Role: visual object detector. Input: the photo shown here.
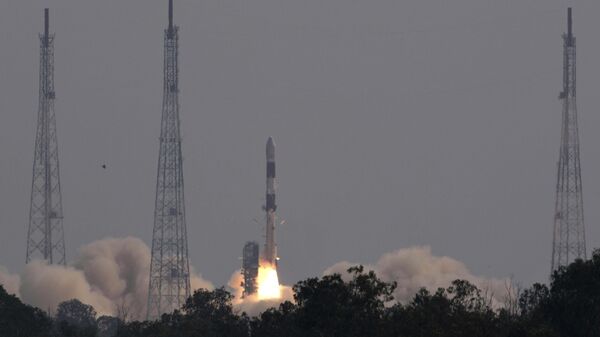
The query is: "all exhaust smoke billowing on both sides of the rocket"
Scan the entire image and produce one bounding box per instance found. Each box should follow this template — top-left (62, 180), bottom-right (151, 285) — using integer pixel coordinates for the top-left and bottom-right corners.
top-left (0, 243), bottom-right (509, 319)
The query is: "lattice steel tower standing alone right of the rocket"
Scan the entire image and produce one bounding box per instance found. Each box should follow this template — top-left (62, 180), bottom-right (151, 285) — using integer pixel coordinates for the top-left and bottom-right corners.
top-left (552, 8), bottom-right (586, 271)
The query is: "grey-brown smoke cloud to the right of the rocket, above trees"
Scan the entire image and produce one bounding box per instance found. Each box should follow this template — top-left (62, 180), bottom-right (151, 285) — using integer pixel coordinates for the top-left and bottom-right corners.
top-left (323, 246), bottom-right (510, 307)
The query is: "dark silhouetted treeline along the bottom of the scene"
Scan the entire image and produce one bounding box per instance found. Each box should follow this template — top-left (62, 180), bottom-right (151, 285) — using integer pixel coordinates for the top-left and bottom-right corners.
top-left (0, 251), bottom-right (600, 337)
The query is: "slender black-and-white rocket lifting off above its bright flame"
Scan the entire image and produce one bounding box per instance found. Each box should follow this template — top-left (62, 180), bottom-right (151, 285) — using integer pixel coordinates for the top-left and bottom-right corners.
top-left (263, 137), bottom-right (277, 266)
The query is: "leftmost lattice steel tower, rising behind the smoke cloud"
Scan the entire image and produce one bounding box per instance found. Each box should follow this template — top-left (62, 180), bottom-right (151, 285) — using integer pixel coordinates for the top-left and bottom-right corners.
top-left (25, 8), bottom-right (66, 265)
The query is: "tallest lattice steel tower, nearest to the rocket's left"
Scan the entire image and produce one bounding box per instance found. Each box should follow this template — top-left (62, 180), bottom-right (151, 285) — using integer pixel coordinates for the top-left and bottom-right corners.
top-left (147, 0), bottom-right (190, 319)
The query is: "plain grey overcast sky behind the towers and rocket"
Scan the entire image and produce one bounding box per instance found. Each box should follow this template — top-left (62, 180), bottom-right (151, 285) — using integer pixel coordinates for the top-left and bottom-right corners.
top-left (0, 0), bottom-right (600, 284)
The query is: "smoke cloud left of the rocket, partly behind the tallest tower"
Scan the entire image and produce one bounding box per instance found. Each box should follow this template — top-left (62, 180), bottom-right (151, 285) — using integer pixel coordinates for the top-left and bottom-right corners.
top-left (0, 237), bottom-right (213, 319)
